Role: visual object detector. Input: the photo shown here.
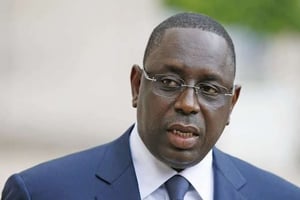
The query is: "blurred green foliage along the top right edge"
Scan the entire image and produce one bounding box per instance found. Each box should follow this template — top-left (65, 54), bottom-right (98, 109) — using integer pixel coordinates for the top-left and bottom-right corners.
top-left (163, 0), bottom-right (300, 33)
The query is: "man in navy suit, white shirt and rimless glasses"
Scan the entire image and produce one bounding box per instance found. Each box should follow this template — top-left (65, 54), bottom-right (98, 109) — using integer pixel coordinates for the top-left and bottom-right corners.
top-left (2, 13), bottom-right (300, 200)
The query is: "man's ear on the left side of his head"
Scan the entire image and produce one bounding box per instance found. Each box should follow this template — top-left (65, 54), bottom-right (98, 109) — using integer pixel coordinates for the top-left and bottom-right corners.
top-left (130, 65), bottom-right (142, 108)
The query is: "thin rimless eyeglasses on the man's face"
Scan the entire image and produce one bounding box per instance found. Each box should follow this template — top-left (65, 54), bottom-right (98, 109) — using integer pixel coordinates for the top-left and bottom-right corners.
top-left (143, 69), bottom-right (234, 103)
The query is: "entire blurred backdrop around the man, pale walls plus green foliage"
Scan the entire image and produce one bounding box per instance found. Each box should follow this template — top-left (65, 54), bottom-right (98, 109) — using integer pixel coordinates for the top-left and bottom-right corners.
top-left (0, 0), bottom-right (300, 190)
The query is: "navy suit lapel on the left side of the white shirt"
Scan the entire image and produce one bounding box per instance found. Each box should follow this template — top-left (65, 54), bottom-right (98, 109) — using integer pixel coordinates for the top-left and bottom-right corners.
top-left (95, 127), bottom-right (140, 200)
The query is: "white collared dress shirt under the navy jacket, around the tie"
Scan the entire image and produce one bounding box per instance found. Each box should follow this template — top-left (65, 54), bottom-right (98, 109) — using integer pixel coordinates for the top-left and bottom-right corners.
top-left (130, 125), bottom-right (214, 200)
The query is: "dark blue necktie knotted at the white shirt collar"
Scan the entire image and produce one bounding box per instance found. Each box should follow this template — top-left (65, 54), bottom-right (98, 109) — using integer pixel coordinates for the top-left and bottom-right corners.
top-left (165, 175), bottom-right (190, 200)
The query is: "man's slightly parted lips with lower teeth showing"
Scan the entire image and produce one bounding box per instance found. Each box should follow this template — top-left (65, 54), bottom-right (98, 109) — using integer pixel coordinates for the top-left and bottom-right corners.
top-left (167, 124), bottom-right (200, 149)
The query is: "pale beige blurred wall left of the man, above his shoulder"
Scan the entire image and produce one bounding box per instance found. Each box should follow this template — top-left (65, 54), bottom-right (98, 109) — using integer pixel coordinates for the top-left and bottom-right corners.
top-left (0, 0), bottom-right (163, 189)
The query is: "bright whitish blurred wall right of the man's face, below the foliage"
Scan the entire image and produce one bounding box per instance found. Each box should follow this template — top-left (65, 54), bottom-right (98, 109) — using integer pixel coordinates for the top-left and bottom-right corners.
top-left (219, 28), bottom-right (300, 186)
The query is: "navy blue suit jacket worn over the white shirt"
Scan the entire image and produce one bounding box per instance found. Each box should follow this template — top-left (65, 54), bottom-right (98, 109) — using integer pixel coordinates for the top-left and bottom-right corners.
top-left (1, 126), bottom-right (300, 200)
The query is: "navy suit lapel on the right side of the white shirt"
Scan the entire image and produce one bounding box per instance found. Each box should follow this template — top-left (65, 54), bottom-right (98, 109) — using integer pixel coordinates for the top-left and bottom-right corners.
top-left (213, 148), bottom-right (246, 200)
